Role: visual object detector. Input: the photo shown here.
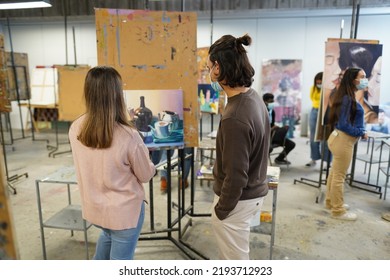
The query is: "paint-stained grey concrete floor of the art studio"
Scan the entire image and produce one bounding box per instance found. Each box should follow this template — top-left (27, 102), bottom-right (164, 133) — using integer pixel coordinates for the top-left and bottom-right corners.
top-left (5, 124), bottom-right (390, 260)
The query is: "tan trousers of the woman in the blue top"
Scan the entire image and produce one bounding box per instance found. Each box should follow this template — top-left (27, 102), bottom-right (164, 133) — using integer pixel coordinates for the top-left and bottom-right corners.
top-left (325, 129), bottom-right (359, 216)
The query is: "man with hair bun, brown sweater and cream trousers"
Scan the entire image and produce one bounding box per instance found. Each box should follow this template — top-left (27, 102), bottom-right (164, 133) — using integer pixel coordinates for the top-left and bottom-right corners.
top-left (207, 34), bottom-right (270, 260)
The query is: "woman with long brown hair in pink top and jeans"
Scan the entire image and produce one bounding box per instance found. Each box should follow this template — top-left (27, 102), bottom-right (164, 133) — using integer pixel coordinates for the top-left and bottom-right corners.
top-left (69, 66), bottom-right (155, 260)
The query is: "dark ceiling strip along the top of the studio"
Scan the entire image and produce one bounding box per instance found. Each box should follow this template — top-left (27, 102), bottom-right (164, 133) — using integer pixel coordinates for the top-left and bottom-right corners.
top-left (0, 0), bottom-right (390, 19)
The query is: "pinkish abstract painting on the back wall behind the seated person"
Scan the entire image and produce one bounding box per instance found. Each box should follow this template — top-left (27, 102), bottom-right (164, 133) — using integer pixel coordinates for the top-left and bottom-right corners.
top-left (261, 59), bottom-right (302, 138)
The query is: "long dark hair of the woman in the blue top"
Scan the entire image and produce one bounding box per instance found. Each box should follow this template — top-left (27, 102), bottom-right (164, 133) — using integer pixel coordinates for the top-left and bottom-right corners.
top-left (329, 67), bottom-right (362, 127)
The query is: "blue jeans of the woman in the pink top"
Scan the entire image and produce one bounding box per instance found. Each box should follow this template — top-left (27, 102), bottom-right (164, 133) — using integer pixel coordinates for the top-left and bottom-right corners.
top-left (93, 203), bottom-right (145, 260)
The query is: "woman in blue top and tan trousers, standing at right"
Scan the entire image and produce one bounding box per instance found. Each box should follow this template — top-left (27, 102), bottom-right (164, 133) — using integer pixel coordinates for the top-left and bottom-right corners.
top-left (325, 67), bottom-right (368, 221)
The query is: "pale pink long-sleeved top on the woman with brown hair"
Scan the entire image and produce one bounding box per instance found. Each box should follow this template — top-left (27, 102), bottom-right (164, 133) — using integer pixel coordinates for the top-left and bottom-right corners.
top-left (69, 116), bottom-right (155, 230)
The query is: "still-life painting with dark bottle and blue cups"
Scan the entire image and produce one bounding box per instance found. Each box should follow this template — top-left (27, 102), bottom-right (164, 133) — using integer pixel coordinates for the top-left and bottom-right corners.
top-left (124, 89), bottom-right (184, 149)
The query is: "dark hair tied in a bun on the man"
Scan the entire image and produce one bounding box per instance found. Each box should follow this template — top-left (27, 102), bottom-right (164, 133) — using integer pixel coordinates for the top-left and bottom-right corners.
top-left (209, 34), bottom-right (255, 88)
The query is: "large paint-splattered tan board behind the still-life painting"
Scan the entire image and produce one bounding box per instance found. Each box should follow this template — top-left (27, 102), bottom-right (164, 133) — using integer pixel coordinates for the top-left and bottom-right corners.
top-left (95, 9), bottom-right (199, 147)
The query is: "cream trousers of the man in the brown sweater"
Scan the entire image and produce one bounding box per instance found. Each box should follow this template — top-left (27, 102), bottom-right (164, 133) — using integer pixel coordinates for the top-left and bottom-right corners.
top-left (211, 195), bottom-right (264, 260)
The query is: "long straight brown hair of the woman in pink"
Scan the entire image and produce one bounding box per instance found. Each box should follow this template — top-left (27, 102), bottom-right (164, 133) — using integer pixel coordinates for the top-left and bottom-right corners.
top-left (78, 66), bottom-right (132, 149)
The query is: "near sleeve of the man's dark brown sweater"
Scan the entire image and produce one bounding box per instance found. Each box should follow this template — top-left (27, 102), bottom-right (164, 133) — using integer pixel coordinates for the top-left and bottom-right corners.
top-left (215, 118), bottom-right (251, 220)
